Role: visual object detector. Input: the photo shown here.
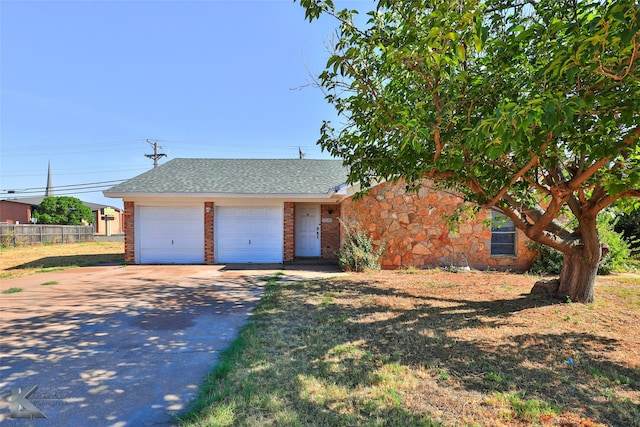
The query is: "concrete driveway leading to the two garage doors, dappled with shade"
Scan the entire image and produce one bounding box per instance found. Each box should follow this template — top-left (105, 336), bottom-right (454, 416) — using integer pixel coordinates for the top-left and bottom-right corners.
top-left (0, 265), bottom-right (344, 427)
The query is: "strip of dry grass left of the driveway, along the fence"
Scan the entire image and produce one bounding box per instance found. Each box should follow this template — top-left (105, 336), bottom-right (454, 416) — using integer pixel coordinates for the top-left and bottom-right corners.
top-left (0, 242), bottom-right (124, 279)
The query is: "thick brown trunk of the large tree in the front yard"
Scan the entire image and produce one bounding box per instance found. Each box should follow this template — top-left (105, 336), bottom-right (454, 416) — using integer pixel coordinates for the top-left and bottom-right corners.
top-left (558, 216), bottom-right (602, 303)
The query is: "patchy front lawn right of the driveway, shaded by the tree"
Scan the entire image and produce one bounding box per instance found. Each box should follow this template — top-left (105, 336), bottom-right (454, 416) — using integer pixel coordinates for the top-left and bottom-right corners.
top-left (181, 270), bottom-right (640, 427)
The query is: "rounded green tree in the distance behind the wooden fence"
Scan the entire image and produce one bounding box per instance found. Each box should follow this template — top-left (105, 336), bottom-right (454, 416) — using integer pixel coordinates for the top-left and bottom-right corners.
top-left (32, 196), bottom-right (93, 225)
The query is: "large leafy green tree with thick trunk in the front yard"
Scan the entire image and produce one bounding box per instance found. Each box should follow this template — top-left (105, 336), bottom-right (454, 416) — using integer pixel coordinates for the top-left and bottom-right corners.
top-left (300, 0), bottom-right (640, 302)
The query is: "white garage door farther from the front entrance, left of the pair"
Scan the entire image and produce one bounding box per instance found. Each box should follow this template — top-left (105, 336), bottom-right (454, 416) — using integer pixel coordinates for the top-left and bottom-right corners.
top-left (136, 206), bottom-right (204, 264)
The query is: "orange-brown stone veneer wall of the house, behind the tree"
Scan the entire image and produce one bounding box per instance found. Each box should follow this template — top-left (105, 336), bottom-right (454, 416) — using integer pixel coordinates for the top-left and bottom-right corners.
top-left (341, 182), bottom-right (536, 270)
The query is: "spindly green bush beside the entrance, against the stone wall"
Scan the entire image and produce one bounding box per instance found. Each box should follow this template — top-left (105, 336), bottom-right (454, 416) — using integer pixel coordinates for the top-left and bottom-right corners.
top-left (338, 221), bottom-right (384, 271)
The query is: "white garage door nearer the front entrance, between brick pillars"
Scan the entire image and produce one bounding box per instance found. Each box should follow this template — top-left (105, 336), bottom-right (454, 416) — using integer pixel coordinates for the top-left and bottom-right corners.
top-left (215, 206), bottom-right (283, 263)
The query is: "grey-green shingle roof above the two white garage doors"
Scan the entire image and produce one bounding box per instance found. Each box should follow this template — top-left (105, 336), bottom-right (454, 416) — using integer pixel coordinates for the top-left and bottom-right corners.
top-left (105, 159), bottom-right (348, 195)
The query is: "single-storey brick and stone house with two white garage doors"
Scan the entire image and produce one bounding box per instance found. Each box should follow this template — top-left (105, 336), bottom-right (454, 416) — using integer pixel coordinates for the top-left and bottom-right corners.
top-left (104, 159), bottom-right (533, 269)
